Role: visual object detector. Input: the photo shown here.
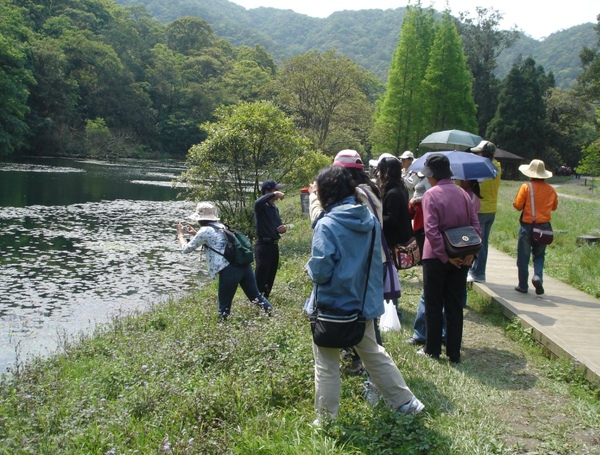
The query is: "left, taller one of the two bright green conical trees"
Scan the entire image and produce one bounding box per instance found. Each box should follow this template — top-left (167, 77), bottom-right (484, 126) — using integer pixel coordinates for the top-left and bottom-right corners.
top-left (372, 4), bottom-right (435, 155)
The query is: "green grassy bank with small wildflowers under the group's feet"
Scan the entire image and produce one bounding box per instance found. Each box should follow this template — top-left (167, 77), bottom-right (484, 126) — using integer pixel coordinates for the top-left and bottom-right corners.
top-left (0, 183), bottom-right (600, 454)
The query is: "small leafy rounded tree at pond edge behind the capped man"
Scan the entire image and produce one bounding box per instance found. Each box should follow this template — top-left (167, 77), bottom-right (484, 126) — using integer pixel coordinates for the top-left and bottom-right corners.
top-left (181, 101), bottom-right (309, 233)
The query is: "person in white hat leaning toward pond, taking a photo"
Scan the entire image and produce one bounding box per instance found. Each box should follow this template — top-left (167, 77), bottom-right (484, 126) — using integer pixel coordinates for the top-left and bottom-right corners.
top-left (177, 202), bottom-right (273, 321)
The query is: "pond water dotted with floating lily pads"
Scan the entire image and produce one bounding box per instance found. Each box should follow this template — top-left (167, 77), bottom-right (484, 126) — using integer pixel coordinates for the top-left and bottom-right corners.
top-left (0, 158), bottom-right (208, 373)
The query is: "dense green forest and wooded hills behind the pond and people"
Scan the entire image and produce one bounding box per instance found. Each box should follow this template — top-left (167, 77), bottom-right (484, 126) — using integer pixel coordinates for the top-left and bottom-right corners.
top-left (0, 0), bottom-right (598, 175)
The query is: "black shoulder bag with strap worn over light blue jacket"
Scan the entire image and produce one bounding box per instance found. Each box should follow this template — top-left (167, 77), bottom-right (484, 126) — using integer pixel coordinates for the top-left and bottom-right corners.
top-left (310, 224), bottom-right (377, 349)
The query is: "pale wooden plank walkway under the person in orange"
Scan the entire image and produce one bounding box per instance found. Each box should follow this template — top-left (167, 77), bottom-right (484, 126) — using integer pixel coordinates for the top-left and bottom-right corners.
top-left (473, 247), bottom-right (600, 385)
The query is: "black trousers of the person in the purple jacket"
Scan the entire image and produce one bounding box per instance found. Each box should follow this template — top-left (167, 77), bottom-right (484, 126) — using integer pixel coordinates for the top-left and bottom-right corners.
top-left (423, 259), bottom-right (469, 361)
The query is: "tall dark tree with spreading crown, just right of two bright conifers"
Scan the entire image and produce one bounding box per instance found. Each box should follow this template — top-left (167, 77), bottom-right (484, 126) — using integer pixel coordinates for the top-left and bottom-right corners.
top-left (457, 7), bottom-right (519, 136)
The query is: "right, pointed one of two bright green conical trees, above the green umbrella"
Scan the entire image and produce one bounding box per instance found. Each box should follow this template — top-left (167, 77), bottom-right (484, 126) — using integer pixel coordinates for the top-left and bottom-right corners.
top-left (421, 11), bottom-right (477, 132)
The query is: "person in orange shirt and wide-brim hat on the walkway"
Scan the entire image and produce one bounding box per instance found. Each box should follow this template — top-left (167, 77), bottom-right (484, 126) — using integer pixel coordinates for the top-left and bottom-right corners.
top-left (513, 159), bottom-right (558, 295)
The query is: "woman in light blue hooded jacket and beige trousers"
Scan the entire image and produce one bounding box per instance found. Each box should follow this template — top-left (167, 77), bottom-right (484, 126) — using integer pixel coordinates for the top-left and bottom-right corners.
top-left (305, 166), bottom-right (425, 424)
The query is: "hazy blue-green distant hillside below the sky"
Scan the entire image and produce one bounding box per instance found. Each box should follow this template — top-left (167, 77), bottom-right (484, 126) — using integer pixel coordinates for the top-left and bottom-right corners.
top-left (116, 0), bottom-right (600, 88)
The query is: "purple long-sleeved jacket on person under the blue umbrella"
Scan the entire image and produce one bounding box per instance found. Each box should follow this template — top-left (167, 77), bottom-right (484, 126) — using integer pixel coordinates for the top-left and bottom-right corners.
top-left (422, 179), bottom-right (481, 264)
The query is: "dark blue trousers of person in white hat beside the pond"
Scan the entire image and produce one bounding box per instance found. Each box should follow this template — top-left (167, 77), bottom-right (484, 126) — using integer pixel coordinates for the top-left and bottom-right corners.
top-left (219, 264), bottom-right (271, 315)
